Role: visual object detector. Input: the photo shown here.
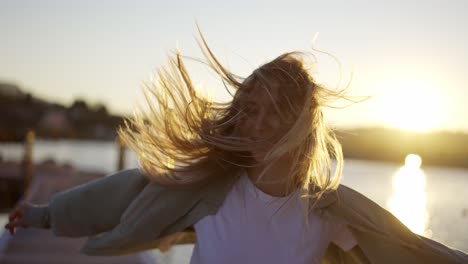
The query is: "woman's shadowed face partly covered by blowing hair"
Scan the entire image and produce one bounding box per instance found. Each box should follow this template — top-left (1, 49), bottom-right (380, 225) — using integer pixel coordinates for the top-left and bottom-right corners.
top-left (239, 85), bottom-right (294, 162)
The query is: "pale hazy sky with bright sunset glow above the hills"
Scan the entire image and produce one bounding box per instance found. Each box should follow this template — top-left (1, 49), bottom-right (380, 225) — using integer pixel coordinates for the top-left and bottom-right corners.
top-left (0, 0), bottom-right (468, 132)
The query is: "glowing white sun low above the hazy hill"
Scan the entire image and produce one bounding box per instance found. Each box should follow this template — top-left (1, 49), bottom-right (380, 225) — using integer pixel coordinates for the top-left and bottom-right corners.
top-left (379, 80), bottom-right (447, 132)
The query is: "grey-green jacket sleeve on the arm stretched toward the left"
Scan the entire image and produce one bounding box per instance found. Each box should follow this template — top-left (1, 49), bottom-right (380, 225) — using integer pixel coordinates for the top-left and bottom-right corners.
top-left (26, 169), bottom-right (149, 237)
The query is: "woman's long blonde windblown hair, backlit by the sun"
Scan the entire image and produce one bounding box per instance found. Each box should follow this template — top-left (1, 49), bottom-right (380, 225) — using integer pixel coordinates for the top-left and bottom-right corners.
top-left (118, 34), bottom-right (352, 206)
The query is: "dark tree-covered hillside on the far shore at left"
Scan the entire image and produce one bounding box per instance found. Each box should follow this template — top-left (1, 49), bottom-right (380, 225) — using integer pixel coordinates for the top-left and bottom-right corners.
top-left (0, 83), bottom-right (123, 141)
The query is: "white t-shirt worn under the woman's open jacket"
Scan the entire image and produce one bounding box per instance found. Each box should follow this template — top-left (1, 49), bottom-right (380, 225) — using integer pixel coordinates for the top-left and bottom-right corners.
top-left (190, 173), bottom-right (357, 264)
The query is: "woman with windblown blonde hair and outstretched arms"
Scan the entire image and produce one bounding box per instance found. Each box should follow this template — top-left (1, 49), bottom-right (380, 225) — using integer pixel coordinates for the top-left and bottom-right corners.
top-left (6, 32), bottom-right (465, 263)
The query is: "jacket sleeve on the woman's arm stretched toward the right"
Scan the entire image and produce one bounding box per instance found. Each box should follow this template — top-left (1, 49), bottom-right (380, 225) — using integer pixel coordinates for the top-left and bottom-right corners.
top-left (325, 185), bottom-right (468, 264)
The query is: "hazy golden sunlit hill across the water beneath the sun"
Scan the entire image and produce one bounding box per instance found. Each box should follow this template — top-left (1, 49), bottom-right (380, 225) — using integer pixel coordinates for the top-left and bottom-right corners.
top-left (337, 128), bottom-right (468, 168)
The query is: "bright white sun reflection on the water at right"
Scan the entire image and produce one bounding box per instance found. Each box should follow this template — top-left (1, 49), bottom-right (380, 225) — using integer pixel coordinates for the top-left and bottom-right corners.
top-left (388, 154), bottom-right (432, 237)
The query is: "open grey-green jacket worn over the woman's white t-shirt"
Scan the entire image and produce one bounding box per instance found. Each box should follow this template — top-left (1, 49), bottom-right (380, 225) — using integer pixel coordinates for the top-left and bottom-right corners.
top-left (27, 169), bottom-right (468, 264)
